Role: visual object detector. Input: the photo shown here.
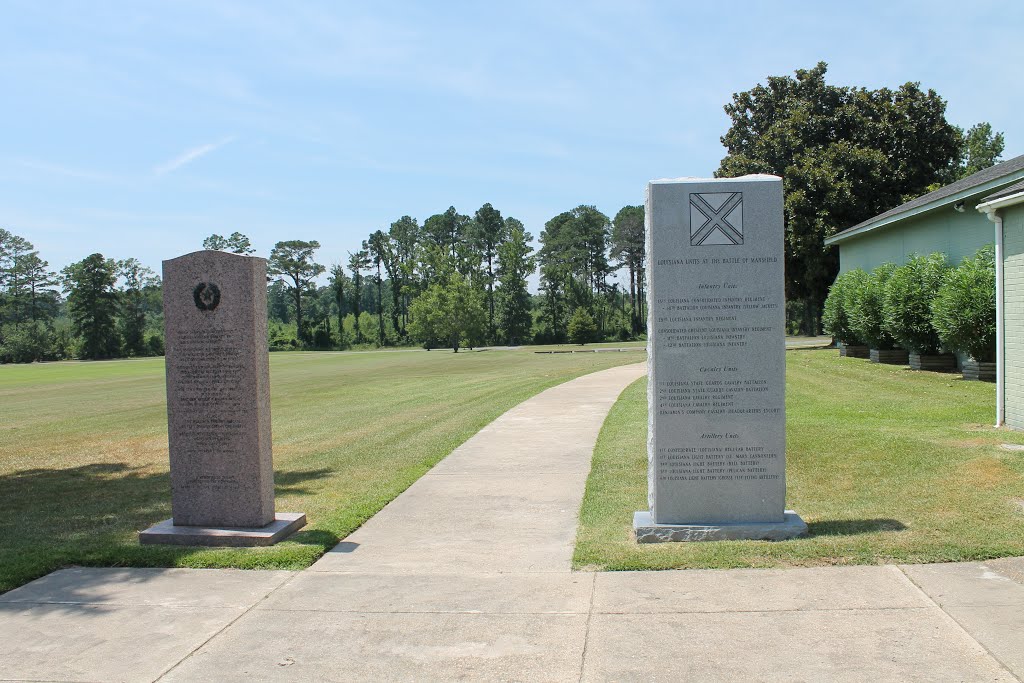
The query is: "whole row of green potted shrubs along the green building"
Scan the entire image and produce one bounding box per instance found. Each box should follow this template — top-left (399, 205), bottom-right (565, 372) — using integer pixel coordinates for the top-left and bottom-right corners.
top-left (822, 246), bottom-right (995, 361)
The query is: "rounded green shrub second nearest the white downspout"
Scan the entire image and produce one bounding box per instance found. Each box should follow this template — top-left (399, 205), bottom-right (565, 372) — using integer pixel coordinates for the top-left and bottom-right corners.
top-left (882, 253), bottom-right (949, 354)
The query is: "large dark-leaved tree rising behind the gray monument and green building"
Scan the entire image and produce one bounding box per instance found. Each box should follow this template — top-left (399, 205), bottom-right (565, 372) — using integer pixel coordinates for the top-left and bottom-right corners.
top-left (716, 61), bottom-right (963, 332)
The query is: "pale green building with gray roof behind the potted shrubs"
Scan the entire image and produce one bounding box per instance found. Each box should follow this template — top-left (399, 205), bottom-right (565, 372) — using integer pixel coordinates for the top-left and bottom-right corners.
top-left (825, 155), bottom-right (1024, 429)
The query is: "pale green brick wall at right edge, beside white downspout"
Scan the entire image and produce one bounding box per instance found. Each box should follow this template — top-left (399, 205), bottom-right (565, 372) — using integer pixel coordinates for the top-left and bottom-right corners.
top-left (999, 204), bottom-right (1024, 429)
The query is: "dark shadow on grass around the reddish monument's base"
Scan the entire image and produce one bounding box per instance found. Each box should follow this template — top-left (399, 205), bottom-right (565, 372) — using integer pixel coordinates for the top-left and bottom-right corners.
top-left (0, 463), bottom-right (339, 593)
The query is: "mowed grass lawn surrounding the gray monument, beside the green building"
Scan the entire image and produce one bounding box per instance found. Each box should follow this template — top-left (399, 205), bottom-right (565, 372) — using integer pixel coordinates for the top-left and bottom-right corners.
top-left (574, 349), bottom-right (1024, 569)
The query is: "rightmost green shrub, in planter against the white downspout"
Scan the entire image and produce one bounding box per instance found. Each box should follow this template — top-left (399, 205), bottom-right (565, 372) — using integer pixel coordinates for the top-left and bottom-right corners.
top-left (932, 246), bottom-right (995, 362)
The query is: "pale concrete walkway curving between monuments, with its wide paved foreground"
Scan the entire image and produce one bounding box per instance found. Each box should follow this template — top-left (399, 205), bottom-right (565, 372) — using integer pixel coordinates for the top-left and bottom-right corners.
top-left (0, 365), bottom-right (1024, 683)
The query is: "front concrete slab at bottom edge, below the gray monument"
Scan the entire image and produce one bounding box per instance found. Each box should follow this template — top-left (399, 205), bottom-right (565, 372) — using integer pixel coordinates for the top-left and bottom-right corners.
top-left (581, 610), bottom-right (1016, 683)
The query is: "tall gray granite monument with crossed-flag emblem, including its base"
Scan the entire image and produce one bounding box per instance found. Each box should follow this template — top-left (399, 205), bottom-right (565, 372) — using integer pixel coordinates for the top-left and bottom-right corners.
top-left (633, 175), bottom-right (807, 543)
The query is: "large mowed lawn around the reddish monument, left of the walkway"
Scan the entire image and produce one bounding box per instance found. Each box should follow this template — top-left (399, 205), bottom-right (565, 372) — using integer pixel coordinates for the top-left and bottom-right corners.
top-left (0, 349), bottom-right (642, 592)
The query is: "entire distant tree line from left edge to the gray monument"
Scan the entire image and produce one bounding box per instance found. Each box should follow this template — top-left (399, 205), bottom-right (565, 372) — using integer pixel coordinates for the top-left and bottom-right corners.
top-left (0, 204), bottom-right (646, 362)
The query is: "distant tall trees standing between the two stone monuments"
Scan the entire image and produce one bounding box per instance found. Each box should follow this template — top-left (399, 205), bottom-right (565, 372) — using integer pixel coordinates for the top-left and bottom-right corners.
top-left (256, 204), bottom-right (645, 351)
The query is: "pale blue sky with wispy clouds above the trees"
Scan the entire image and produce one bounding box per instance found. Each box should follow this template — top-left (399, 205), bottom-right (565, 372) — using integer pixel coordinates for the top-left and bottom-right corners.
top-left (0, 0), bottom-right (1024, 282)
